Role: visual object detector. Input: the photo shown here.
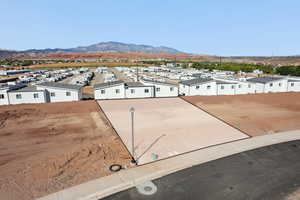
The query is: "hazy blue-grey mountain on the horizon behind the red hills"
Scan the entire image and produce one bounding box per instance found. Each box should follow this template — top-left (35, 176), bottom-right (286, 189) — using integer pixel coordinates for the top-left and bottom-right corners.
top-left (23, 42), bottom-right (183, 54)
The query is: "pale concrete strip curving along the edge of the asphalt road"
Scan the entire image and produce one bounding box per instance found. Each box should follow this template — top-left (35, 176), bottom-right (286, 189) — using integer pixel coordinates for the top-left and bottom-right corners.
top-left (38, 130), bottom-right (300, 200)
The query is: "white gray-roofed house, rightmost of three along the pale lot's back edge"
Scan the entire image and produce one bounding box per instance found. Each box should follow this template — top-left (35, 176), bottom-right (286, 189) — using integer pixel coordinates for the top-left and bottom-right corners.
top-left (140, 79), bottom-right (178, 97)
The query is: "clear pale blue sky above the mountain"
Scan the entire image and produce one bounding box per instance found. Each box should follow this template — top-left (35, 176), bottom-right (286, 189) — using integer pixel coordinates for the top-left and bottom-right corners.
top-left (0, 0), bottom-right (300, 56)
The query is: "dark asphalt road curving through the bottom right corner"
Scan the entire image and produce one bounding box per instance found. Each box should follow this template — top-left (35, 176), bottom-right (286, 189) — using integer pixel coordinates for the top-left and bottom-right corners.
top-left (105, 140), bottom-right (300, 200)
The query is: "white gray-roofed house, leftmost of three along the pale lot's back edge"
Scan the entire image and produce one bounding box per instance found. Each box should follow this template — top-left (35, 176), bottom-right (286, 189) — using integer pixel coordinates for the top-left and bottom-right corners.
top-left (94, 81), bottom-right (125, 99)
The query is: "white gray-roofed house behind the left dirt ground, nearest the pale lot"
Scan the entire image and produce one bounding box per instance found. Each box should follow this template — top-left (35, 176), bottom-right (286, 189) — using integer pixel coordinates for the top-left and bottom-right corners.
top-left (36, 82), bottom-right (82, 102)
